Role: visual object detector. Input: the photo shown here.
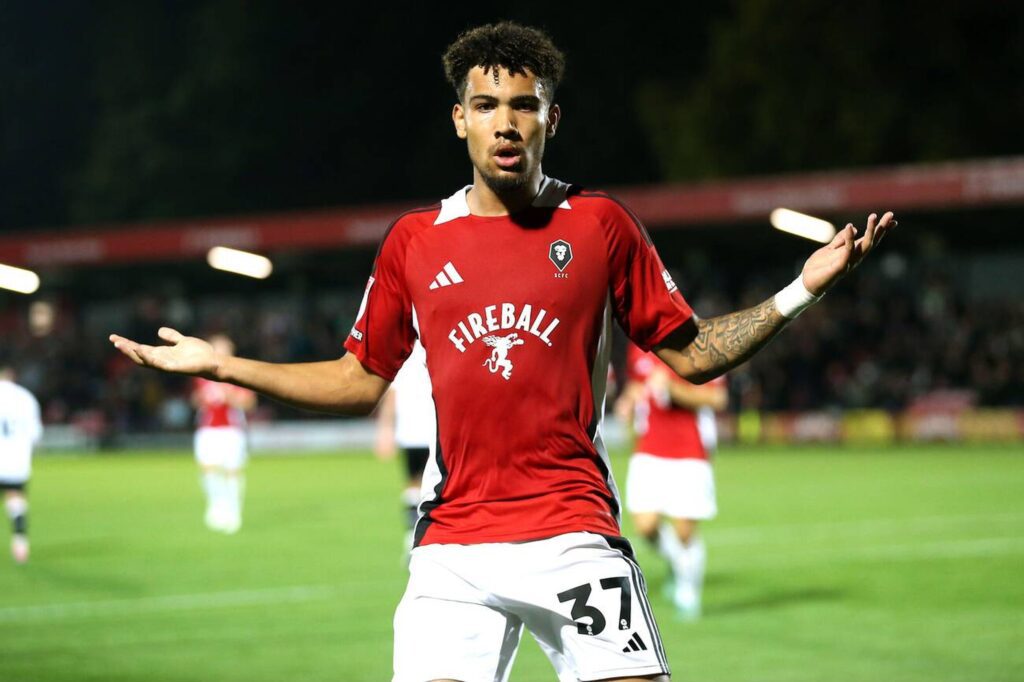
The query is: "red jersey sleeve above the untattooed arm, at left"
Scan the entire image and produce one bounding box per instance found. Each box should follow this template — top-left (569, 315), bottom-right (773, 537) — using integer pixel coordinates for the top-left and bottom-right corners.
top-left (345, 227), bottom-right (417, 381)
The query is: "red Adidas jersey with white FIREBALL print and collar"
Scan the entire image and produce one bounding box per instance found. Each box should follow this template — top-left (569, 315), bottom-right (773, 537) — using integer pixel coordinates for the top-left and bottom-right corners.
top-left (345, 178), bottom-right (692, 545)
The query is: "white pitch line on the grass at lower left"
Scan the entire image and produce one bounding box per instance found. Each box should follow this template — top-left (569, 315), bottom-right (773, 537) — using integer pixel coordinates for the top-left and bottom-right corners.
top-left (0, 585), bottom-right (341, 624)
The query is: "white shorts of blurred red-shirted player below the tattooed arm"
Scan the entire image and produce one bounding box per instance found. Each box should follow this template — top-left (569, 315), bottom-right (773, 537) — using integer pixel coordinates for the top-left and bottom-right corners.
top-left (626, 453), bottom-right (718, 520)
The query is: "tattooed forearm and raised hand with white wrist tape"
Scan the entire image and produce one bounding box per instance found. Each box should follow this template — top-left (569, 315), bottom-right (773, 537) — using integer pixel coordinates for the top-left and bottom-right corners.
top-left (654, 212), bottom-right (896, 383)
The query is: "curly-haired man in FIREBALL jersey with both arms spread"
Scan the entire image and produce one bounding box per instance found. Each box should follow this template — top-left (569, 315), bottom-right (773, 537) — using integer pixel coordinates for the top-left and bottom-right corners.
top-left (111, 23), bottom-right (894, 682)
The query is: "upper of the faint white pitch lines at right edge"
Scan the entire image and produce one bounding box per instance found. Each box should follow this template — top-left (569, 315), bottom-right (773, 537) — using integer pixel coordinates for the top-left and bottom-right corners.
top-left (708, 512), bottom-right (1024, 545)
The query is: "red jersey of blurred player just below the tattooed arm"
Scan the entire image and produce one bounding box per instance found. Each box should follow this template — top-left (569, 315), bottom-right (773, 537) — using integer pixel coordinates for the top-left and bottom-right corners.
top-left (626, 344), bottom-right (725, 460)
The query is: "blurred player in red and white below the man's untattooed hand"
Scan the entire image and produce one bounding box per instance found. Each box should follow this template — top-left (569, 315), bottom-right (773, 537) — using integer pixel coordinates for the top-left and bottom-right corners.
top-left (191, 335), bottom-right (256, 534)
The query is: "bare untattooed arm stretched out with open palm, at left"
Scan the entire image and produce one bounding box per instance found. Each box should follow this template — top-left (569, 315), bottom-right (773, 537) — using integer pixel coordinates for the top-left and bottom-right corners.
top-left (111, 327), bottom-right (389, 415)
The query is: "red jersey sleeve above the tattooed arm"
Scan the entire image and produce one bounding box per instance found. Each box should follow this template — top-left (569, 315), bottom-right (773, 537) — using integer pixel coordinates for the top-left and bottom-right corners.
top-left (605, 198), bottom-right (693, 351)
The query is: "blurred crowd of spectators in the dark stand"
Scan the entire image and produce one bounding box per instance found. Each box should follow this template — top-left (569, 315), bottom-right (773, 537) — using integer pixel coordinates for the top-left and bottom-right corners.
top-left (0, 258), bottom-right (1024, 433)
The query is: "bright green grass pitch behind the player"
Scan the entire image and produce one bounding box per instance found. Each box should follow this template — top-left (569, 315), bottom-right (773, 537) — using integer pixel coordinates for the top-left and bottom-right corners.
top-left (0, 445), bottom-right (1024, 682)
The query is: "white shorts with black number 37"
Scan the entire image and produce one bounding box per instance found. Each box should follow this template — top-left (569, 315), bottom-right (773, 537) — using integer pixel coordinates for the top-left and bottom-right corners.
top-left (394, 532), bottom-right (669, 682)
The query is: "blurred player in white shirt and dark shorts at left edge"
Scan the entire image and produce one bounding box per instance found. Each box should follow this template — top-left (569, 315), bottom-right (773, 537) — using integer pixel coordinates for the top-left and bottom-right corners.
top-left (0, 364), bottom-right (43, 563)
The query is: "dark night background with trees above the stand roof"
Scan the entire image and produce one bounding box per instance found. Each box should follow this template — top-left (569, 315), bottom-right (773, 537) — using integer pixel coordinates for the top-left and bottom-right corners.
top-left (0, 0), bottom-right (1024, 229)
